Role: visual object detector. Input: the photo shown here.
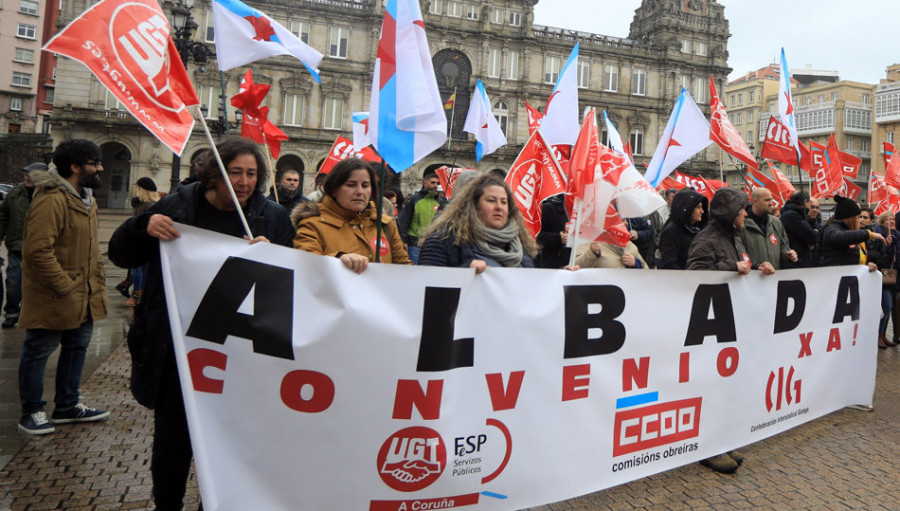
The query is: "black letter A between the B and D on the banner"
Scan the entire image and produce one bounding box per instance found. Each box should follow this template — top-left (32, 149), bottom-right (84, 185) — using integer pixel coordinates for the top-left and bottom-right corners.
top-left (684, 284), bottom-right (737, 346)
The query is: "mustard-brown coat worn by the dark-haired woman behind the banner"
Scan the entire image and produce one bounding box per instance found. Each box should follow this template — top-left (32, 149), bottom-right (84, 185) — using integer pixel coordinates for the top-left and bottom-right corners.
top-left (291, 195), bottom-right (412, 264)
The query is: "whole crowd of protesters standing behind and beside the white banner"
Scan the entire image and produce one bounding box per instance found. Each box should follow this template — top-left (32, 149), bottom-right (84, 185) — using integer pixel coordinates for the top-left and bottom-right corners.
top-left (8, 137), bottom-right (900, 510)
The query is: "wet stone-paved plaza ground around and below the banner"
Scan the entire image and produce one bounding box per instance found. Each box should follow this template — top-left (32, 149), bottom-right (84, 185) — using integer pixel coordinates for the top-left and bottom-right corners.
top-left (0, 210), bottom-right (900, 511)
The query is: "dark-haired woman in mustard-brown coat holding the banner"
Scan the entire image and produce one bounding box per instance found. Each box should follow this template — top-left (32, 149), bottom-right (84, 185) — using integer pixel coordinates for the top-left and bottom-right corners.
top-left (291, 158), bottom-right (412, 273)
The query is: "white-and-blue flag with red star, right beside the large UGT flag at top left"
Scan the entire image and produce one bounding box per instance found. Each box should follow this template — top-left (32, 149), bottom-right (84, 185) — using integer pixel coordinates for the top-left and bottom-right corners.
top-left (212, 0), bottom-right (322, 82)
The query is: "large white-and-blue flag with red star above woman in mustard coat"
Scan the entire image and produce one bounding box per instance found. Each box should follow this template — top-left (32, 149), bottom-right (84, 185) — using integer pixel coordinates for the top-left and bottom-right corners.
top-left (369, 0), bottom-right (447, 172)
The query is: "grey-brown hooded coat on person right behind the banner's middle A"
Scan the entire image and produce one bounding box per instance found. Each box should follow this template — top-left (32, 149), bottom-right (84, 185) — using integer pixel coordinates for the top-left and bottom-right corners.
top-left (687, 188), bottom-right (750, 271)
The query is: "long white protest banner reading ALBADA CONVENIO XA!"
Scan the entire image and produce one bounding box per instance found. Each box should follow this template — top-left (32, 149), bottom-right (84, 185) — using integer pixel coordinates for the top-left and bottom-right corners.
top-left (161, 226), bottom-right (881, 510)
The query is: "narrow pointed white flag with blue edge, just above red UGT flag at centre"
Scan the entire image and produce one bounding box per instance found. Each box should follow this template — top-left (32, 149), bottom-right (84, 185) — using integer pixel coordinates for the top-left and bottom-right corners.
top-left (540, 43), bottom-right (580, 145)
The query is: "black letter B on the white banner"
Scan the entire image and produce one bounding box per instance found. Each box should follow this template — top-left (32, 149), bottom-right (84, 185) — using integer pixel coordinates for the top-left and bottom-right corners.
top-left (563, 286), bottom-right (625, 358)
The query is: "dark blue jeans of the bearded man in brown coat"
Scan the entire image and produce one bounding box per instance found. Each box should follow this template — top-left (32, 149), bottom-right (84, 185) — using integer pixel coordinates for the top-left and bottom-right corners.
top-left (19, 321), bottom-right (94, 414)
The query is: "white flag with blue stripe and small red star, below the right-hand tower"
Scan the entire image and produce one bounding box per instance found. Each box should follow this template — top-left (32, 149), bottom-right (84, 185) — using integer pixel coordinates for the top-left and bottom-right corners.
top-left (644, 88), bottom-right (712, 188)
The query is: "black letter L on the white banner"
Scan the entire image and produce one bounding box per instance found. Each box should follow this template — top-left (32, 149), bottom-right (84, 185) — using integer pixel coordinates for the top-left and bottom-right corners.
top-left (416, 287), bottom-right (475, 371)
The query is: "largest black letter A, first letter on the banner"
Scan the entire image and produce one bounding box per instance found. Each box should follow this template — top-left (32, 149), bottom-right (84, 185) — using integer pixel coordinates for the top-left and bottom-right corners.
top-left (187, 257), bottom-right (294, 360)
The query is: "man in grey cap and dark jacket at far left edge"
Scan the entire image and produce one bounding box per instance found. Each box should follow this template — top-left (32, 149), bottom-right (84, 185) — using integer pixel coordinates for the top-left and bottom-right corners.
top-left (0, 162), bottom-right (38, 328)
